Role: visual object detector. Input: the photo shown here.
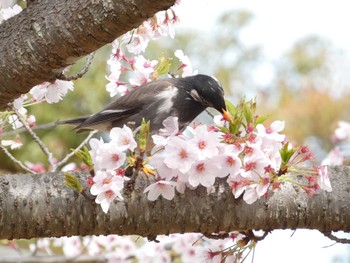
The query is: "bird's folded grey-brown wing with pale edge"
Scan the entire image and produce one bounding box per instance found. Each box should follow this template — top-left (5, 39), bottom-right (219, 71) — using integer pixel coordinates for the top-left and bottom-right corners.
top-left (75, 79), bottom-right (173, 130)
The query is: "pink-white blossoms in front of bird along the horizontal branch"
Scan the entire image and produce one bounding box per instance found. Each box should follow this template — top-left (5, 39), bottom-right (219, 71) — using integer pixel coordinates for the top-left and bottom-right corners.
top-left (86, 112), bottom-right (331, 216)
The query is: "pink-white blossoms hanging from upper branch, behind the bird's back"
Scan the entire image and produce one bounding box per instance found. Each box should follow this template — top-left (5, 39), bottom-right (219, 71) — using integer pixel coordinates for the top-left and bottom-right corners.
top-left (106, 5), bottom-right (198, 97)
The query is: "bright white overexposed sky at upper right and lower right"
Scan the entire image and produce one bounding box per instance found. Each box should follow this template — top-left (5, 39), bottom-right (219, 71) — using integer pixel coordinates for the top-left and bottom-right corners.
top-left (176, 0), bottom-right (350, 263)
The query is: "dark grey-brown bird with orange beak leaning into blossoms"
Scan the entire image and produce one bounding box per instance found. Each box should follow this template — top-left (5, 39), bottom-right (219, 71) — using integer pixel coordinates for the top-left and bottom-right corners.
top-left (59, 74), bottom-right (230, 139)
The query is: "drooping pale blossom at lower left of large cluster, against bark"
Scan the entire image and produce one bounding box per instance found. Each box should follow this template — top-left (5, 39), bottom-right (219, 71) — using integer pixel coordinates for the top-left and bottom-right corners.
top-left (143, 180), bottom-right (176, 201)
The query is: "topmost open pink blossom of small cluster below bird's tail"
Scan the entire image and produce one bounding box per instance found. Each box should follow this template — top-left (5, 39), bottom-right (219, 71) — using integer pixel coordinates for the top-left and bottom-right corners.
top-left (109, 125), bottom-right (137, 151)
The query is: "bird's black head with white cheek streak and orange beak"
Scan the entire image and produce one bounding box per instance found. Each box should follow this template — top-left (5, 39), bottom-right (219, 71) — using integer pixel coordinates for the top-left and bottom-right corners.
top-left (188, 74), bottom-right (230, 120)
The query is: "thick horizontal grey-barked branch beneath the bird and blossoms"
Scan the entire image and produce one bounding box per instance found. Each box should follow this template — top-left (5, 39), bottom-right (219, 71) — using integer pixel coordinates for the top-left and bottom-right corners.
top-left (0, 166), bottom-right (350, 239)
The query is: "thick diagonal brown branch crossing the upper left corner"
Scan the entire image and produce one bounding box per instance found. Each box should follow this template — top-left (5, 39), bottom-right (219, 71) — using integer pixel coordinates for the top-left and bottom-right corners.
top-left (0, 0), bottom-right (175, 109)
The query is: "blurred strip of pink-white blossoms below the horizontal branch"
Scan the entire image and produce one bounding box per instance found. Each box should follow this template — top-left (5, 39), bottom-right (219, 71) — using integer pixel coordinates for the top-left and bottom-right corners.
top-left (18, 231), bottom-right (246, 262)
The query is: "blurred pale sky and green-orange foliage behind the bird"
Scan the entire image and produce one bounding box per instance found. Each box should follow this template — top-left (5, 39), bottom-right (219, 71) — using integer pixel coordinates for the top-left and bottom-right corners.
top-left (0, 0), bottom-right (350, 263)
